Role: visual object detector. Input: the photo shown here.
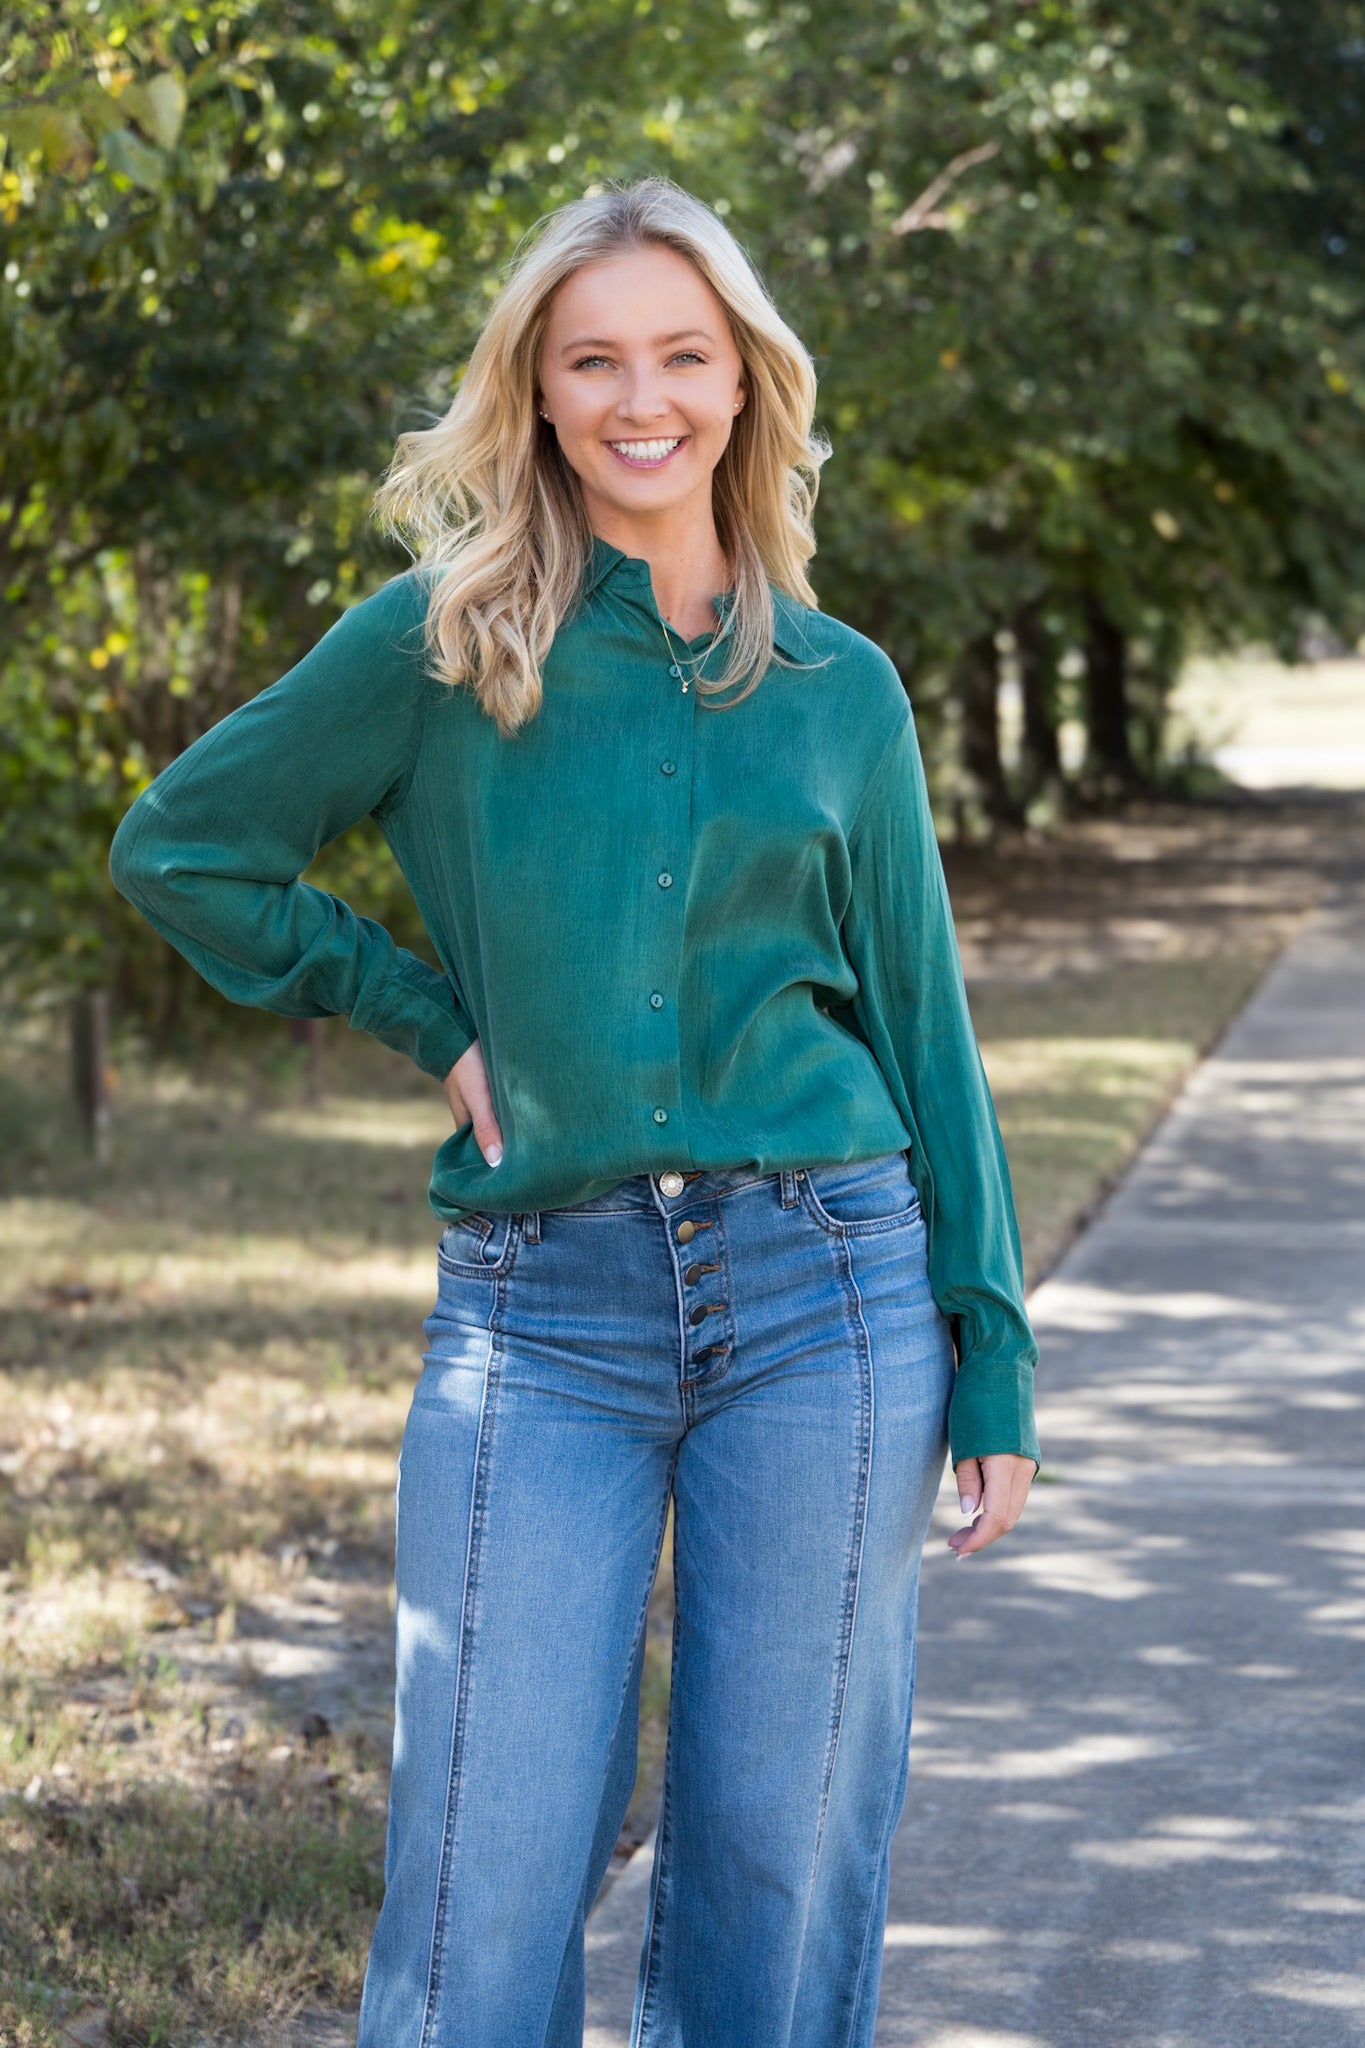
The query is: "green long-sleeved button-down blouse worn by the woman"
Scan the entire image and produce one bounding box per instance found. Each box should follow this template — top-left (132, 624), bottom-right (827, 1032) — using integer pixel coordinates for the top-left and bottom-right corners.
top-left (111, 541), bottom-right (1038, 1462)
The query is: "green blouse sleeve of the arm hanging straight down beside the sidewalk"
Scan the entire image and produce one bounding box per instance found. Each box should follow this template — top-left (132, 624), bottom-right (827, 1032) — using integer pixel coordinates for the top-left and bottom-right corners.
top-left (843, 702), bottom-right (1040, 1464)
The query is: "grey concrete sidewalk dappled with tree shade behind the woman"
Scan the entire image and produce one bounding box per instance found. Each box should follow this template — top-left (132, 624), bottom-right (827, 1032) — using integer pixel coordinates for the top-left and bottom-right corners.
top-left (585, 891), bottom-right (1365, 2048)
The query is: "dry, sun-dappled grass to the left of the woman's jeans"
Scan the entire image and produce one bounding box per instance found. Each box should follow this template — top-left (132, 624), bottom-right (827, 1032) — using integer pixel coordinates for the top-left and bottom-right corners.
top-left (0, 1044), bottom-right (440, 2048)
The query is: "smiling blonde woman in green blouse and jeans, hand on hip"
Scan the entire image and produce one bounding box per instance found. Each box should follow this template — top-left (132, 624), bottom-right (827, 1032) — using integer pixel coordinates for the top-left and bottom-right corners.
top-left (113, 178), bottom-right (1038, 2048)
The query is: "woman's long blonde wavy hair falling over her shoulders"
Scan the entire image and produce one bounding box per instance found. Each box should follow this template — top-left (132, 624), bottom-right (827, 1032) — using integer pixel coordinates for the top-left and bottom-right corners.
top-left (372, 178), bottom-right (829, 735)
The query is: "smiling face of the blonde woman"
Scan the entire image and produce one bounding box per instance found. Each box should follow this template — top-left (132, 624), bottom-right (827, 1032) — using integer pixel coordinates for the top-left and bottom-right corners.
top-left (536, 244), bottom-right (745, 539)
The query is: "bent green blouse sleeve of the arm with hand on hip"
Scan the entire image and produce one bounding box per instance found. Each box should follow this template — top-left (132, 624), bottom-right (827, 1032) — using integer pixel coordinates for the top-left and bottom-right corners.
top-left (108, 580), bottom-right (477, 1079)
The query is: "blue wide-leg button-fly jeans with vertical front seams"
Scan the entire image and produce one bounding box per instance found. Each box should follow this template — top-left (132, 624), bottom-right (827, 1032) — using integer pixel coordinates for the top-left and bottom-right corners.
top-left (358, 1153), bottom-right (954, 2048)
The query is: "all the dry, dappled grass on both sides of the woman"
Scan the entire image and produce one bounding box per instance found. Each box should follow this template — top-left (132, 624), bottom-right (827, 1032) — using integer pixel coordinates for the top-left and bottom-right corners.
top-left (0, 790), bottom-right (1363, 2048)
